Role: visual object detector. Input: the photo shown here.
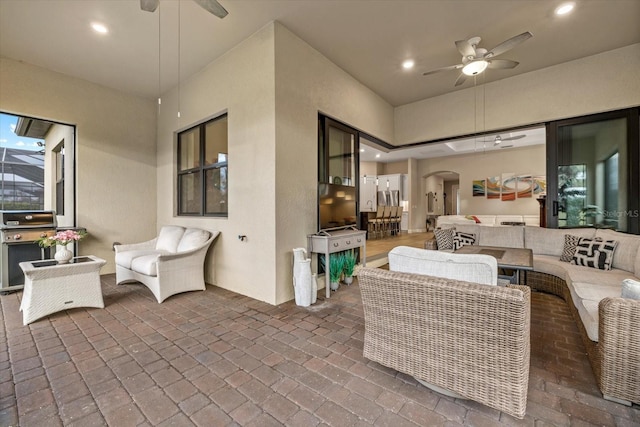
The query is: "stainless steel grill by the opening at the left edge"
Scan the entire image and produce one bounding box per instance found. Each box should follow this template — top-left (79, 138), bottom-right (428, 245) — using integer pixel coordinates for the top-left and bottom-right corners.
top-left (0, 211), bottom-right (56, 292)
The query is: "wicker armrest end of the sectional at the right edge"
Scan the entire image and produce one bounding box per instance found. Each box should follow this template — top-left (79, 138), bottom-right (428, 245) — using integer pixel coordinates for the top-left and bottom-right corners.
top-left (598, 298), bottom-right (640, 404)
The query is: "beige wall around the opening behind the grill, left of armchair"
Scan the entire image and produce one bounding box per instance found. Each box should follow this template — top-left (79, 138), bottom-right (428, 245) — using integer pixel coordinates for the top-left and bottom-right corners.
top-left (0, 58), bottom-right (156, 274)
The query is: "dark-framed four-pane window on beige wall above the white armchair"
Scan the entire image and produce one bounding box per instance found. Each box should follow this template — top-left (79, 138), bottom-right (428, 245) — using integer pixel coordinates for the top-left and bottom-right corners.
top-left (178, 114), bottom-right (229, 217)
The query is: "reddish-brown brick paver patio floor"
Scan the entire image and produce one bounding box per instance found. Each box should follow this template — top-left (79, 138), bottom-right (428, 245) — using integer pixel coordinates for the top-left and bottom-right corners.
top-left (0, 275), bottom-right (640, 427)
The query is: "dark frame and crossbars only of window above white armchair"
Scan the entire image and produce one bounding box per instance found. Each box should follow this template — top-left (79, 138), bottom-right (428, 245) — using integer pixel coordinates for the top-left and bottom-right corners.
top-left (176, 113), bottom-right (229, 218)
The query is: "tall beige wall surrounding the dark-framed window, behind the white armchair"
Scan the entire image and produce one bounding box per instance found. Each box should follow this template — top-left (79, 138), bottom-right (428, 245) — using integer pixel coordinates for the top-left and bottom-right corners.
top-left (157, 25), bottom-right (276, 304)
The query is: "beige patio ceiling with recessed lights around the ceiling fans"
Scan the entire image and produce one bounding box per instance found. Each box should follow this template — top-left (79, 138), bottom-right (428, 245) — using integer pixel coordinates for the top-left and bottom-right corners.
top-left (0, 0), bottom-right (640, 106)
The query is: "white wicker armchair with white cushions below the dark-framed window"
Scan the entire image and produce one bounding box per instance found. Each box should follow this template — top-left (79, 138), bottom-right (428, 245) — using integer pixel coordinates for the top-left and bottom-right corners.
top-left (114, 226), bottom-right (220, 303)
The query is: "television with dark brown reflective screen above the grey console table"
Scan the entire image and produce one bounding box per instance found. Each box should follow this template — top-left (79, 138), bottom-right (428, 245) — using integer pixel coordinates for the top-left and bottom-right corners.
top-left (318, 183), bottom-right (358, 230)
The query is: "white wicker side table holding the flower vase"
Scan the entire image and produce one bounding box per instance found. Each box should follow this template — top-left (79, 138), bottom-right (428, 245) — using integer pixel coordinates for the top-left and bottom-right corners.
top-left (20, 256), bottom-right (106, 325)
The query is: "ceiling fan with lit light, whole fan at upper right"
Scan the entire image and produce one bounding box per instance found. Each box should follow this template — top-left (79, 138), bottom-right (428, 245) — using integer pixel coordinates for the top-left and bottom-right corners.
top-left (423, 31), bottom-right (533, 86)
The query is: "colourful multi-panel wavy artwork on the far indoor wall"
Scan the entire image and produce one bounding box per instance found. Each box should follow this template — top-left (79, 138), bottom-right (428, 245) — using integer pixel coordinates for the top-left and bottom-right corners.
top-left (472, 172), bottom-right (547, 201)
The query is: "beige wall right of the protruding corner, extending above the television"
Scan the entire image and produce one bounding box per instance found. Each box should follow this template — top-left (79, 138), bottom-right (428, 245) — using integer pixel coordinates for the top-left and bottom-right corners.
top-left (275, 23), bottom-right (393, 302)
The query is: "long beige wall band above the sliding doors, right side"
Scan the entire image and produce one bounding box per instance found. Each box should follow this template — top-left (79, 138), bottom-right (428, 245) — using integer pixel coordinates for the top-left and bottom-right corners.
top-left (394, 44), bottom-right (640, 145)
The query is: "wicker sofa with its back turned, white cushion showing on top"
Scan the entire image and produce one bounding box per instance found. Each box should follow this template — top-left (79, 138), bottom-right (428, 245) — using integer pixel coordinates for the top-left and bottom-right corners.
top-left (358, 247), bottom-right (530, 418)
